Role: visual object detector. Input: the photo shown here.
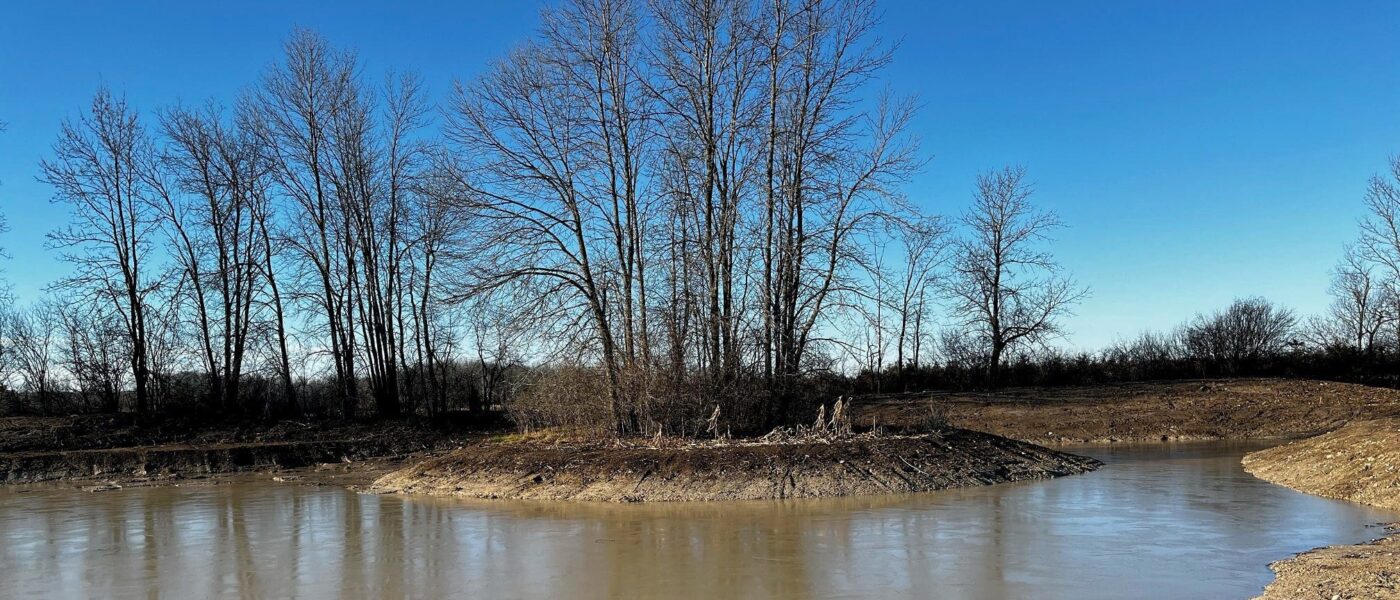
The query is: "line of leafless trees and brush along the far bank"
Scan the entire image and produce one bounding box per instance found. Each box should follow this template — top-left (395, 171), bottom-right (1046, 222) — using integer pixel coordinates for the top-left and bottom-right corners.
top-left (32, 0), bottom-right (1344, 435)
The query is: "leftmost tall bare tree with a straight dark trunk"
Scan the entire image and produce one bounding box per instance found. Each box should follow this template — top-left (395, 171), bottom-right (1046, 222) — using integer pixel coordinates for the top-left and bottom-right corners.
top-left (41, 88), bottom-right (158, 413)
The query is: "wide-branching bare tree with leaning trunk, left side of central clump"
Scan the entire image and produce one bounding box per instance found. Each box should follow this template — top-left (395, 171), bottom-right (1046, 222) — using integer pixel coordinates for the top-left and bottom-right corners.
top-left (447, 1), bottom-right (650, 428)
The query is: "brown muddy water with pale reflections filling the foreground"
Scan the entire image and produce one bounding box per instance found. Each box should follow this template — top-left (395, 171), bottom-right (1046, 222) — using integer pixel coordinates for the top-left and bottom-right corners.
top-left (0, 443), bottom-right (1400, 600)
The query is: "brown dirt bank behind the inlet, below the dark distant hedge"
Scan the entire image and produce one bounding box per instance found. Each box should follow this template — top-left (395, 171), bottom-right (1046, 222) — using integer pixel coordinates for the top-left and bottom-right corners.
top-left (855, 379), bottom-right (1400, 443)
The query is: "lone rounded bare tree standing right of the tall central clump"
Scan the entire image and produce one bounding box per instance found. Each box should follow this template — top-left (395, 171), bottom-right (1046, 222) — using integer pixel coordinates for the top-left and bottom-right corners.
top-left (948, 166), bottom-right (1088, 386)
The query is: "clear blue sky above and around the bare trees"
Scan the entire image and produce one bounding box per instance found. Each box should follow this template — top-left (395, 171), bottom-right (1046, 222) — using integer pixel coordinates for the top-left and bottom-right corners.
top-left (0, 0), bottom-right (1400, 347)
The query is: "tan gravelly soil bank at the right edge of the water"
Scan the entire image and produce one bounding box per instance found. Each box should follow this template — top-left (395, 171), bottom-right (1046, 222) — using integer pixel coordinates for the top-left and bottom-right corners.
top-left (1243, 420), bottom-right (1400, 600)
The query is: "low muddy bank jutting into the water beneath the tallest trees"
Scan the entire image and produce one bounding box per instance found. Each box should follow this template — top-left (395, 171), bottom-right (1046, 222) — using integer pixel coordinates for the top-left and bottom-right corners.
top-left (371, 429), bottom-right (1100, 502)
